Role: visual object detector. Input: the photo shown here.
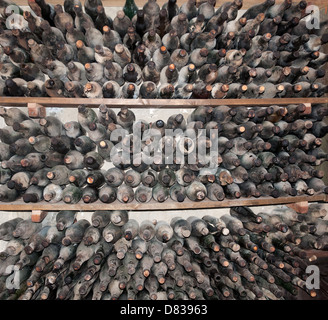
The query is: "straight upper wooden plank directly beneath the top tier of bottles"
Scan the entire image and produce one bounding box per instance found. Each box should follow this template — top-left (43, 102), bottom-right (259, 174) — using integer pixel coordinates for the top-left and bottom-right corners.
top-left (0, 97), bottom-right (328, 109)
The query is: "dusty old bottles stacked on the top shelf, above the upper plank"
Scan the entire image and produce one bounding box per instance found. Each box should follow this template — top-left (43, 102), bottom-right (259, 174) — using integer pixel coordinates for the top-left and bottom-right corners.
top-left (0, 0), bottom-right (328, 99)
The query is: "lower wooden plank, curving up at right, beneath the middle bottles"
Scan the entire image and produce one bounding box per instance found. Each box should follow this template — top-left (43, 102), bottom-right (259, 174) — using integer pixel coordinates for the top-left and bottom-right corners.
top-left (0, 194), bottom-right (327, 211)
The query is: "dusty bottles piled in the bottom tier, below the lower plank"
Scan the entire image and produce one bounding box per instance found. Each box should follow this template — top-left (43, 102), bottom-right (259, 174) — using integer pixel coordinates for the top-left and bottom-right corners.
top-left (0, 204), bottom-right (328, 300)
